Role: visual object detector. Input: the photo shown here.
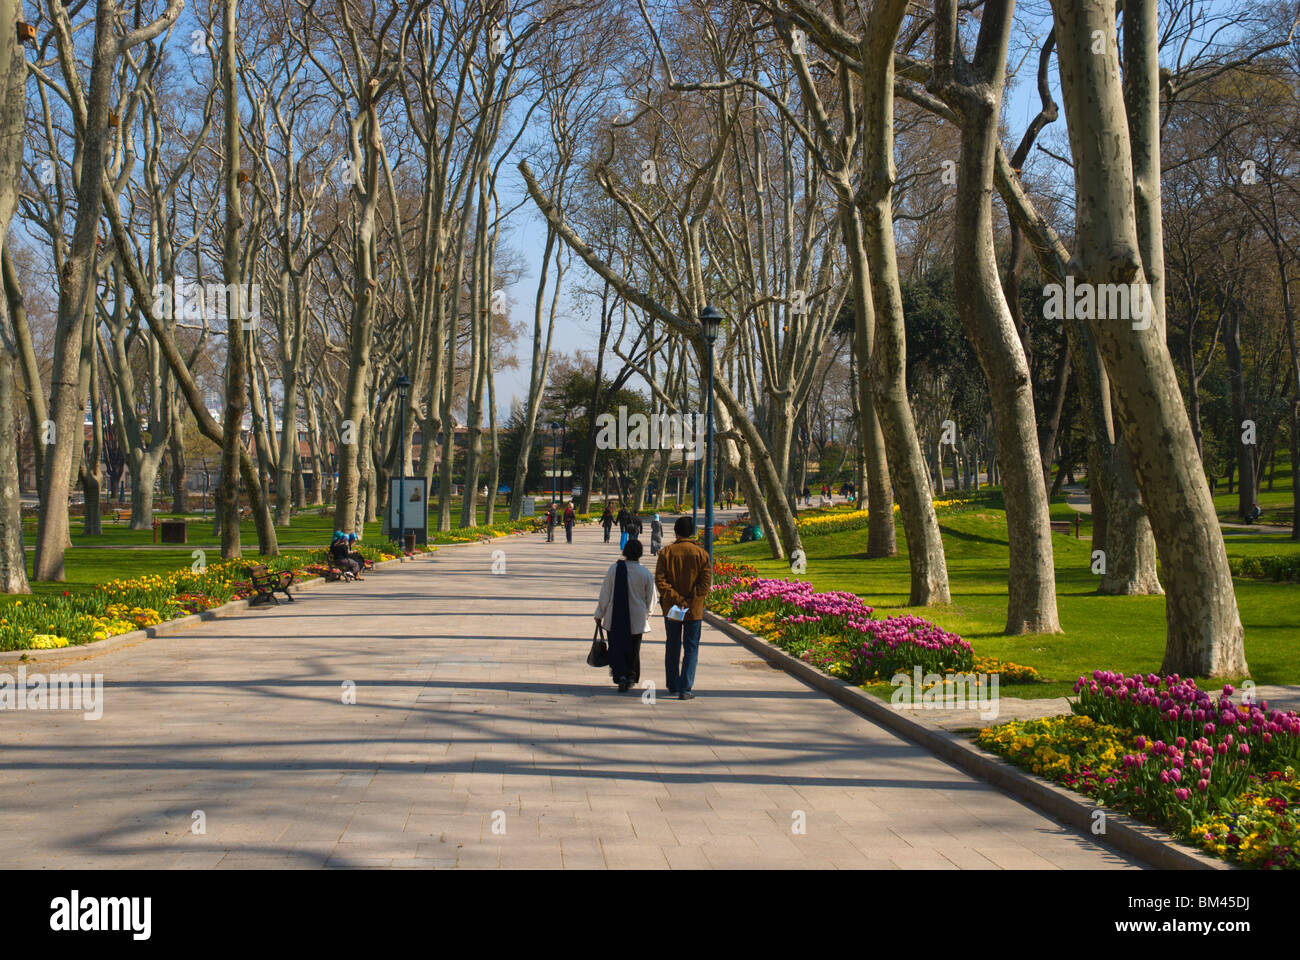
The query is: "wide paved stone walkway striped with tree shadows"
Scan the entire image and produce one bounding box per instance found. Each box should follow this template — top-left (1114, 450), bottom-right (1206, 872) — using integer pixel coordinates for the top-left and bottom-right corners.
top-left (0, 527), bottom-right (1132, 869)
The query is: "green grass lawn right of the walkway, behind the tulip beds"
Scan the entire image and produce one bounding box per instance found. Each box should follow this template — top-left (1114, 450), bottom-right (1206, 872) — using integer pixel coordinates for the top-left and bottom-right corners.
top-left (719, 494), bottom-right (1300, 697)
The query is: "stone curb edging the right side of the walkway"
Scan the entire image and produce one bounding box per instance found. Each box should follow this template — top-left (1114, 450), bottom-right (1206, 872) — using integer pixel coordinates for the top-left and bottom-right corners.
top-left (705, 610), bottom-right (1239, 870)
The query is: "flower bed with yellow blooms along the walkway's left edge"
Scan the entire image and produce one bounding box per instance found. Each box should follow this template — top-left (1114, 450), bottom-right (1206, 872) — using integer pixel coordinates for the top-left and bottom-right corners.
top-left (0, 544), bottom-right (394, 650)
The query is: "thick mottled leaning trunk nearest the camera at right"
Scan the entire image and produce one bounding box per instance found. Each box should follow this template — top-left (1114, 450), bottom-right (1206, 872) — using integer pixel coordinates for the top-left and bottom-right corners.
top-left (1050, 0), bottom-right (1247, 676)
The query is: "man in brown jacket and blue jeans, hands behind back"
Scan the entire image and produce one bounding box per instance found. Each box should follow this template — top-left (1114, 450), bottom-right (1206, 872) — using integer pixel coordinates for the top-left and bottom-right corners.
top-left (654, 516), bottom-right (714, 700)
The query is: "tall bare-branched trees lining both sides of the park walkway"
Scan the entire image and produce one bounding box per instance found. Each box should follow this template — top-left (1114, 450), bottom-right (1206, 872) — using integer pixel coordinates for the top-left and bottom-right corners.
top-left (0, 0), bottom-right (1300, 674)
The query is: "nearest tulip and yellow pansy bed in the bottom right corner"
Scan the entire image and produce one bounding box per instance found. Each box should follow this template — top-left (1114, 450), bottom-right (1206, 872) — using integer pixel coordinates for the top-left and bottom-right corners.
top-left (978, 670), bottom-right (1300, 869)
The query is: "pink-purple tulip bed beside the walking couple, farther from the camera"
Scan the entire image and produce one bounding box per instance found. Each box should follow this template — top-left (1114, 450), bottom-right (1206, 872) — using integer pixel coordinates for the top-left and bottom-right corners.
top-left (709, 563), bottom-right (975, 684)
